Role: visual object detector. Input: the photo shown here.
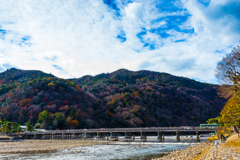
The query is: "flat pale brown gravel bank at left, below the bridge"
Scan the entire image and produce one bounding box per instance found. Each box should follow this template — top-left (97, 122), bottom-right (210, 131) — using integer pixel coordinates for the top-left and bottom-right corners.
top-left (0, 140), bottom-right (107, 154)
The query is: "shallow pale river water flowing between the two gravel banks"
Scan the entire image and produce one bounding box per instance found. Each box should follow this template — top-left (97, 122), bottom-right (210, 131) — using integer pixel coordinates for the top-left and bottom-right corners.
top-left (0, 136), bottom-right (207, 160)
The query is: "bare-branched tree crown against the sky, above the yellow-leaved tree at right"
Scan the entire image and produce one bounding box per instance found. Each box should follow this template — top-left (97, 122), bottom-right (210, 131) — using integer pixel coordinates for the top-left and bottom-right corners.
top-left (216, 46), bottom-right (240, 97)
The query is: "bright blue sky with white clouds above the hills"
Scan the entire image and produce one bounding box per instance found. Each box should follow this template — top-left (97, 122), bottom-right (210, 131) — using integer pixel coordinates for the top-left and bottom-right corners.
top-left (0, 0), bottom-right (240, 84)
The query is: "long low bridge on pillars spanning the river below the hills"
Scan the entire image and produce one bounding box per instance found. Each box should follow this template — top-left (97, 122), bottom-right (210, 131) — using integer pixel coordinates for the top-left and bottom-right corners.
top-left (25, 127), bottom-right (216, 142)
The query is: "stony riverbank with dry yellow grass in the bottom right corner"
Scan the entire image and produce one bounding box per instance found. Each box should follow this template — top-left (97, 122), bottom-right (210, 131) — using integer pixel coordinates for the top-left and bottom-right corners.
top-left (154, 135), bottom-right (240, 160)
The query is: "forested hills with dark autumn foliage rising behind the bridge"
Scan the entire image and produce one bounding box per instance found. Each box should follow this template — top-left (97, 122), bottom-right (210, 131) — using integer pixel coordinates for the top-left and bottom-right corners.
top-left (0, 69), bottom-right (226, 128)
